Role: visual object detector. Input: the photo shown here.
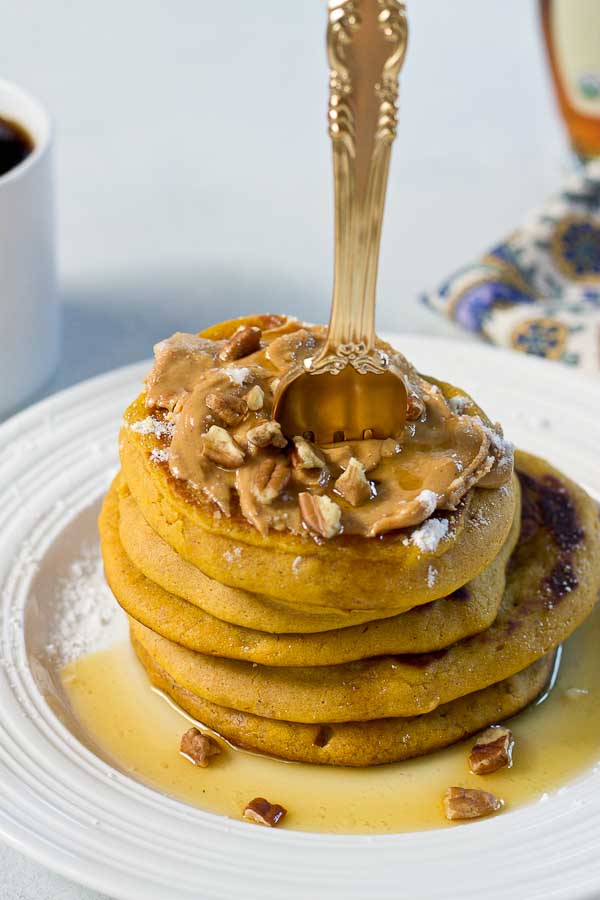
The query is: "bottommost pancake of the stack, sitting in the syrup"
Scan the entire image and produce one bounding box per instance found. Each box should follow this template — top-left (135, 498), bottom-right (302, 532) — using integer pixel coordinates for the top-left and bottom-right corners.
top-left (132, 635), bottom-right (554, 766)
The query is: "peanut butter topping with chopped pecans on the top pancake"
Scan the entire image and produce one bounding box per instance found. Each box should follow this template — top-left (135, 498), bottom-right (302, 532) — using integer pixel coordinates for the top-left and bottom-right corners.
top-left (133, 317), bottom-right (513, 539)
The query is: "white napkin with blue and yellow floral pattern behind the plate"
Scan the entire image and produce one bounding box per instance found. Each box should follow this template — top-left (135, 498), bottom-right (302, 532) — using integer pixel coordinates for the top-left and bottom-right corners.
top-left (422, 159), bottom-right (600, 375)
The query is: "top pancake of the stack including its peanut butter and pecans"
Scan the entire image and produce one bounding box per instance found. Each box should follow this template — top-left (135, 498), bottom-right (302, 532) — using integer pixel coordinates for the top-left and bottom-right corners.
top-left (120, 315), bottom-right (516, 612)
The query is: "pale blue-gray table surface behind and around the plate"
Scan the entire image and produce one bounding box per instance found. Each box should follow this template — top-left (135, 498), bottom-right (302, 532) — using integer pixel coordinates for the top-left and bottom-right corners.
top-left (0, 0), bottom-right (567, 900)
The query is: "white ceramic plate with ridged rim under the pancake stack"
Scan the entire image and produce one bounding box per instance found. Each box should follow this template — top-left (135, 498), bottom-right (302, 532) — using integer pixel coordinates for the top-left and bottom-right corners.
top-left (0, 336), bottom-right (600, 900)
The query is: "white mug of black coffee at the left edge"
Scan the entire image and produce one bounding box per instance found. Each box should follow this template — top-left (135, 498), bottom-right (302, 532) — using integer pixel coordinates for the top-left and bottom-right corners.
top-left (0, 80), bottom-right (60, 416)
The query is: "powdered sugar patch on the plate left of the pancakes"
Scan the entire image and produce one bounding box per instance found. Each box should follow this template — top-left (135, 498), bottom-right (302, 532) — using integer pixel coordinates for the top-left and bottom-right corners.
top-left (46, 546), bottom-right (124, 665)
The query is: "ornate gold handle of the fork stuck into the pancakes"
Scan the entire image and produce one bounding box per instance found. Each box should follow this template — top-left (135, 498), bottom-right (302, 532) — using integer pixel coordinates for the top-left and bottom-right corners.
top-left (309, 0), bottom-right (408, 374)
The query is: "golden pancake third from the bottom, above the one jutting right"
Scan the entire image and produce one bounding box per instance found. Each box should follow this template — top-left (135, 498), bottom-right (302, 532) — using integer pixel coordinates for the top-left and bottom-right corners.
top-left (99, 479), bottom-right (520, 666)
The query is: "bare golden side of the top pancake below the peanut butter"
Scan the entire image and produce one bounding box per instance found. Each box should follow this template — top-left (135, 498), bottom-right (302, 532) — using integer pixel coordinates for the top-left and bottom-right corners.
top-left (120, 412), bottom-right (517, 612)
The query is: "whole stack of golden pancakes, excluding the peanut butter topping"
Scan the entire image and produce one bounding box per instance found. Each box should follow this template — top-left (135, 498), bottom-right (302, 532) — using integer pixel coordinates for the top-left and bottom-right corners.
top-left (100, 323), bottom-right (600, 766)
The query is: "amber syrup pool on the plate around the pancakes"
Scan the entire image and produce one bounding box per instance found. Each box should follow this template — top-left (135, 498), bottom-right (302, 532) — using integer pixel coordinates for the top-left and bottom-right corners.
top-left (58, 609), bottom-right (600, 834)
